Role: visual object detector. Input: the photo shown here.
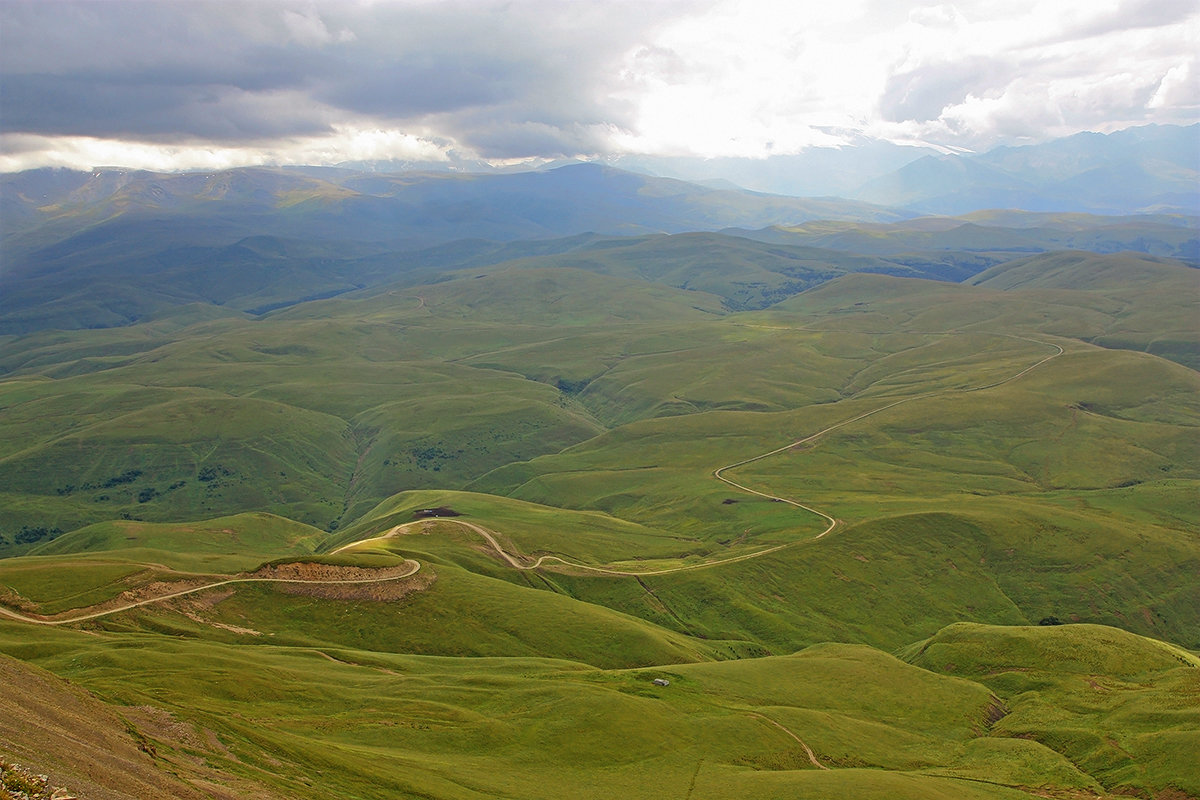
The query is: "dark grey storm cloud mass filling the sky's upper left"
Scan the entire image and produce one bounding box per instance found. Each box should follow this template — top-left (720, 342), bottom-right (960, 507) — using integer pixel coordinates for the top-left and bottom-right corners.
top-left (0, 1), bottom-right (680, 157)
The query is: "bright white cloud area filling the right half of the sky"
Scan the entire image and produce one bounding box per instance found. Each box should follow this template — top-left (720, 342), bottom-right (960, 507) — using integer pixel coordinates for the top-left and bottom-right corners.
top-left (604, 0), bottom-right (1200, 156)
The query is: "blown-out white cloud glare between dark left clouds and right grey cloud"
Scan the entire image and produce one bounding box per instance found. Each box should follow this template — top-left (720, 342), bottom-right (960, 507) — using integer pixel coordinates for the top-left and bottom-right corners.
top-left (609, 0), bottom-right (884, 156)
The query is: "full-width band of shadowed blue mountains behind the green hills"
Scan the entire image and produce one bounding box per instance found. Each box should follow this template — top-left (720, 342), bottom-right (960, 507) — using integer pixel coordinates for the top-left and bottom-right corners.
top-left (0, 154), bottom-right (1200, 333)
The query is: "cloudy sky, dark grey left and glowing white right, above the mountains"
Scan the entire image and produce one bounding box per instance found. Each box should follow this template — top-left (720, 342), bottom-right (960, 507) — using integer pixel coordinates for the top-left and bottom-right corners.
top-left (0, 0), bottom-right (1200, 172)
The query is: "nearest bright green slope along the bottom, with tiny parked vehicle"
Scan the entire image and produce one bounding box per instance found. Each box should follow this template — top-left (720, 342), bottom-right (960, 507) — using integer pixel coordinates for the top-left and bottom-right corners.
top-left (0, 596), bottom-right (1200, 800)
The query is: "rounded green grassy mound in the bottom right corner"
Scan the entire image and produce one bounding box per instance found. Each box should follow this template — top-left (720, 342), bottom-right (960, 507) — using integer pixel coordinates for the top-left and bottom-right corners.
top-left (905, 624), bottom-right (1200, 795)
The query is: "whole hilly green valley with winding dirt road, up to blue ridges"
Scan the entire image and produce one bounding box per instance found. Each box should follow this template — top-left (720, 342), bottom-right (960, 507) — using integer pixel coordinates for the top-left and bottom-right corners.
top-left (0, 169), bottom-right (1200, 800)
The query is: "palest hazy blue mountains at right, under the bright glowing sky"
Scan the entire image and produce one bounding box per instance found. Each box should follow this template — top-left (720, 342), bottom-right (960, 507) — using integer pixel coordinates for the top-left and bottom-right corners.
top-left (321, 125), bottom-right (1200, 215)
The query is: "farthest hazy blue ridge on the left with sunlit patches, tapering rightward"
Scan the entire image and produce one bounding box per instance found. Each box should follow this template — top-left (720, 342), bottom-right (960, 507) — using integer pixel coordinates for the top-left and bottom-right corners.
top-left (0, 164), bottom-right (912, 255)
